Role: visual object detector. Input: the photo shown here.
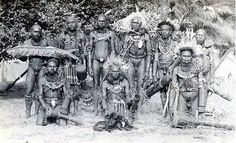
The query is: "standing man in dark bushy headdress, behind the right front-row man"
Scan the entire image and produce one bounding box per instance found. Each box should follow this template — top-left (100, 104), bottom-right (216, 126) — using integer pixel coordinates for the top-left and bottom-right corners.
top-left (153, 21), bottom-right (177, 111)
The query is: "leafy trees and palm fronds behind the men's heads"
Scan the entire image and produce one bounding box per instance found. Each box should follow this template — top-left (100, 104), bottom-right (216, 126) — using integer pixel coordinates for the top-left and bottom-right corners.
top-left (0, 0), bottom-right (235, 60)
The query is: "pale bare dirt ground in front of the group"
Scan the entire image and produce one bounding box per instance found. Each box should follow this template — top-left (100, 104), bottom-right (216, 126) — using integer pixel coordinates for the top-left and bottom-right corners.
top-left (0, 84), bottom-right (235, 143)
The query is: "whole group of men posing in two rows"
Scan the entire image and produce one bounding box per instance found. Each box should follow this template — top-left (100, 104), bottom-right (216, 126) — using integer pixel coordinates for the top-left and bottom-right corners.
top-left (23, 14), bottom-right (214, 128)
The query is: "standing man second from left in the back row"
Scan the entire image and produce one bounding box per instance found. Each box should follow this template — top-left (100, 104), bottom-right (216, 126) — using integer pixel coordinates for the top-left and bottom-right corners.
top-left (58, 16), bottom-right (86, 113)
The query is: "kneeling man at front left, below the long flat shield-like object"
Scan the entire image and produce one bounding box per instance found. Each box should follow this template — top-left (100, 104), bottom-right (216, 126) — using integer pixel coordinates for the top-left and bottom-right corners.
top-left (36, 58), bottom-right (70, 126)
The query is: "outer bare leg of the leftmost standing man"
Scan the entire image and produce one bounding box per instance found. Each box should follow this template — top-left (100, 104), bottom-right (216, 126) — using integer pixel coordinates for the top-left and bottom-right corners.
top-left (25, 67), bottom-right (35, 118)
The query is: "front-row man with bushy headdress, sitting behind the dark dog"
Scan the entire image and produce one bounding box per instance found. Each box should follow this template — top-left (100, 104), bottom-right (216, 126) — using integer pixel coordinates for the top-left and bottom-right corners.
top-left (102, 59), bottom-right (139, 124)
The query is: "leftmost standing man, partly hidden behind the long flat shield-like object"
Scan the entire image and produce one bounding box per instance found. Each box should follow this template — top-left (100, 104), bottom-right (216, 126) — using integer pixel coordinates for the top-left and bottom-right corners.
top-left (23, 23), bottom-right (47, 118)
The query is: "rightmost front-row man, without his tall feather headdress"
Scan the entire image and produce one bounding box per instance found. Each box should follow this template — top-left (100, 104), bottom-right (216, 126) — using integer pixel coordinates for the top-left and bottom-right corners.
top-left (169, 47), bottom-right (205, 117)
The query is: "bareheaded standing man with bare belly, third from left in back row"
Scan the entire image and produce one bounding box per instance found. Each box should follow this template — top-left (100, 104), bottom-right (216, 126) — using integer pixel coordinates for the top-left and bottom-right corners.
top-left (89, 14), bottom-right (115, 88)
